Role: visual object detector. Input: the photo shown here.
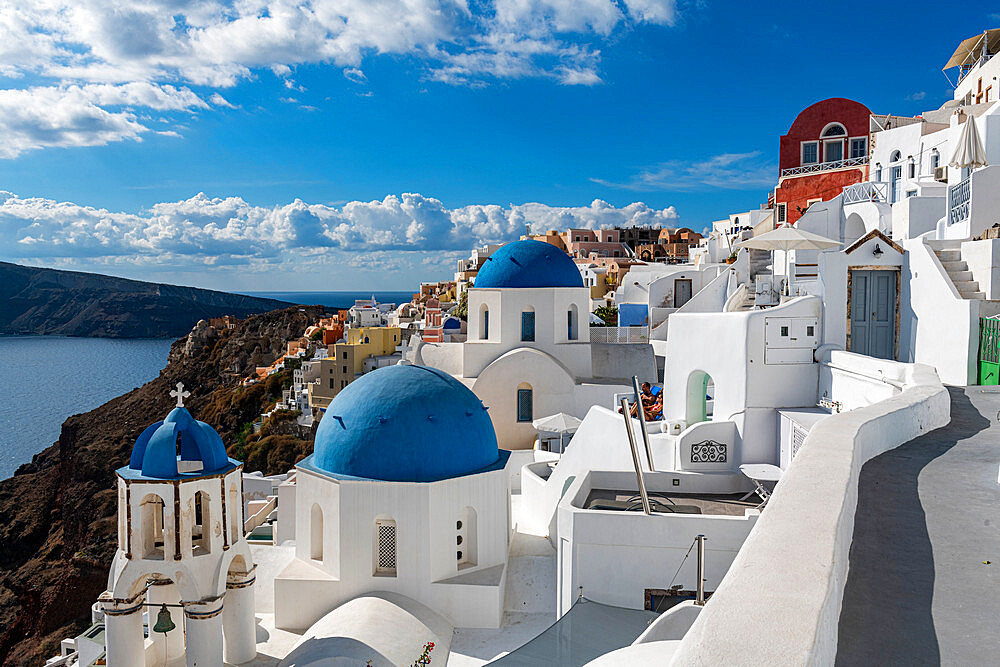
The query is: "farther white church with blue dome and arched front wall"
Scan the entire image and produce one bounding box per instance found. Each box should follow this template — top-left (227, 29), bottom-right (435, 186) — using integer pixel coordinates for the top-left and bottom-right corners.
top-left (405, 240), bottom-right (656, 449)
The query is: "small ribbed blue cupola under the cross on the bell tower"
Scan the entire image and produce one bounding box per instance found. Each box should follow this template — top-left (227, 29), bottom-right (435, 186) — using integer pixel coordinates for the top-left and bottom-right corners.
top-left (123, 408), bottom-right (234, 479)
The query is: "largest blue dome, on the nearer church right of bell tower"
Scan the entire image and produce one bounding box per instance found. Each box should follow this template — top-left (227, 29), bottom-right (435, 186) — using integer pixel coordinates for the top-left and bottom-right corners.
top-left (310, 365), bottom-right (501, 482)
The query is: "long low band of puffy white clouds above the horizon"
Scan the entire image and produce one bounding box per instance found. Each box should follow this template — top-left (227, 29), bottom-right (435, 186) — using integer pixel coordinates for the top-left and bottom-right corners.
top-left (0, 191), bottom-right (678, 266)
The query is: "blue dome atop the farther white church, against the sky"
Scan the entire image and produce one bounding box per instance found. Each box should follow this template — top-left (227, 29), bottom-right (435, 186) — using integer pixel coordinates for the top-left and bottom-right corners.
top-left (474, 239), bottom-right (583, 287)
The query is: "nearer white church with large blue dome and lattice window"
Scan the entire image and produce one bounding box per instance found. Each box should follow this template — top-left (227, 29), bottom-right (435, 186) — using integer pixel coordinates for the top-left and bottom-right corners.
top-left (275, 365), bottom-right (510, 633)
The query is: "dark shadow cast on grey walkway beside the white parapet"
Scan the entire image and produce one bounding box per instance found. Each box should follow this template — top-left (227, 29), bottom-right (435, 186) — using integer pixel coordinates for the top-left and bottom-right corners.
top-left (836, 387), bottom-right (990, 666)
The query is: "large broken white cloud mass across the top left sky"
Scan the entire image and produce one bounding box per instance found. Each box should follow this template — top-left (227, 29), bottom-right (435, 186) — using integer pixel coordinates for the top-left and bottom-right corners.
top-left (0, 0), bottom-right (676, 158)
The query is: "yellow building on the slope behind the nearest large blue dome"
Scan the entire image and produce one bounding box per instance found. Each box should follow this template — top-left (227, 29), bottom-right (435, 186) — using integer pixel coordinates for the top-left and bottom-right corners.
top-left (309, 327), bottom-right (400, 409)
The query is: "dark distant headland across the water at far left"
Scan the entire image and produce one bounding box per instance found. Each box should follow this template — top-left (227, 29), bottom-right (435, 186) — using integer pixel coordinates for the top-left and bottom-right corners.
top-left (0, 262), bottom-right (291, 338)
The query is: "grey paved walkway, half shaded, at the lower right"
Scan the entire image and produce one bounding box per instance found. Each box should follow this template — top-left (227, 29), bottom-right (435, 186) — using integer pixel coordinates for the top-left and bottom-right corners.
top-left (837, 387), bottom-right (1000, 665)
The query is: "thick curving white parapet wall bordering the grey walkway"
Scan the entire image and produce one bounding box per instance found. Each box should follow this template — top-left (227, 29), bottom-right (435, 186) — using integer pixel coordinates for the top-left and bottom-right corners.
top-left (671, 365), bottom-right (950, 665)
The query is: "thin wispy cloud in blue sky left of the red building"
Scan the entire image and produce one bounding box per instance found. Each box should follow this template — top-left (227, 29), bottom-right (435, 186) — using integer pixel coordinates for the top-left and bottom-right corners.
top-left (590, 151), bottom-right (778, 191)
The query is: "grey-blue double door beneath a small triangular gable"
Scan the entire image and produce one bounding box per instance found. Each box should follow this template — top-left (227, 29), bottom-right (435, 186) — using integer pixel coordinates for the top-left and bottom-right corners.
top-left (850, 271), bottom-right (896, 359)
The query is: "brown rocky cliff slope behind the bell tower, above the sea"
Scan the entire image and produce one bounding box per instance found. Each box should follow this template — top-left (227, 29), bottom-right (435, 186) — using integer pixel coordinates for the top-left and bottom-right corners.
top-left (0, 308), bottom-right (322, 665)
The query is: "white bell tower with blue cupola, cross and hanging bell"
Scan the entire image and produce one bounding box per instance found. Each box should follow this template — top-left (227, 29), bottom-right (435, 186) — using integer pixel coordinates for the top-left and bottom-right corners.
top-left (100, 383), bottom-right (256, 667)
